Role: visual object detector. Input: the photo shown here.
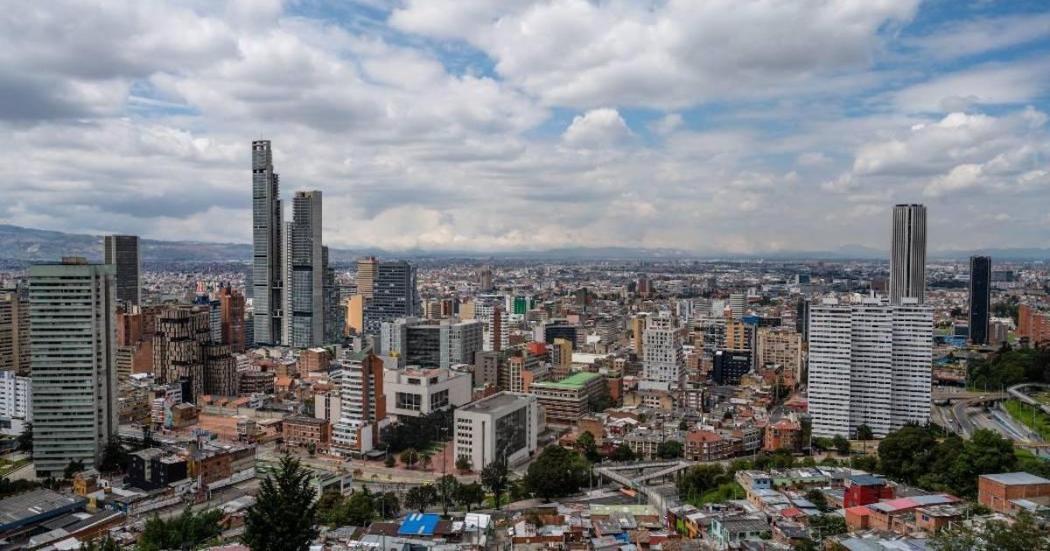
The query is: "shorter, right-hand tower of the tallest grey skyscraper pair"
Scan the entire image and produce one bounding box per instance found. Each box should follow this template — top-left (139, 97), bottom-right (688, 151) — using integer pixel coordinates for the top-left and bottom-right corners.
top-left (284, 191), bottom-right (327, 348)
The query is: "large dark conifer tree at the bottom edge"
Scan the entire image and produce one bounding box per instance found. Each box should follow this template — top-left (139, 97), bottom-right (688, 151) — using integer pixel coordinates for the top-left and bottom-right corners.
top-left (244, 454), bottom-right (317, 551)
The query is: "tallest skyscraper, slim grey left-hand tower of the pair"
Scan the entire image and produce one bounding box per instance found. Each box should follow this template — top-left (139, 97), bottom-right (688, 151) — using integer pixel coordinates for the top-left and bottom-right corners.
top-left (252, 140), bottom-right (284, 344)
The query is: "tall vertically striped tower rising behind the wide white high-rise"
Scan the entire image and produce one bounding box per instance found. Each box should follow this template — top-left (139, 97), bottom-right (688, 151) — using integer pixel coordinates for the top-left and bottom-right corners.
top-left (889, 205), bottom-right (926, 304)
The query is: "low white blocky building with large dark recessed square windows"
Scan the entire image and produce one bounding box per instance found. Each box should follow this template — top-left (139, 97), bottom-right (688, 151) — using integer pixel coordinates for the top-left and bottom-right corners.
top-left (383, 366), bottom-right (471, 417)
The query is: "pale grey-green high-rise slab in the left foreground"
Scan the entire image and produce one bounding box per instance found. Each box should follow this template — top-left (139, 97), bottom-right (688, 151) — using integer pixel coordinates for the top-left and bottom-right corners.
top-left (29, 258), bottom-right (118, 478)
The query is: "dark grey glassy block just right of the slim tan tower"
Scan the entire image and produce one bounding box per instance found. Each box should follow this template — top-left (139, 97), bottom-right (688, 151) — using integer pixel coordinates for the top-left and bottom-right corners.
top-left (358, 260), bottom-right (419, 335)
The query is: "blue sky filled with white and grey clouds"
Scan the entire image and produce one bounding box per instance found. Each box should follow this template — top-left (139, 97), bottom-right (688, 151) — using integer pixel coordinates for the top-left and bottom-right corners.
top-left (0, 0), bottom-right (1050, 253)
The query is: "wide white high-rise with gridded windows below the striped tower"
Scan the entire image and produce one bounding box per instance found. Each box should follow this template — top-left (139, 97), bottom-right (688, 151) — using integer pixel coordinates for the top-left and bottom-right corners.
top-left (809, 298), bottom-right (933, 437)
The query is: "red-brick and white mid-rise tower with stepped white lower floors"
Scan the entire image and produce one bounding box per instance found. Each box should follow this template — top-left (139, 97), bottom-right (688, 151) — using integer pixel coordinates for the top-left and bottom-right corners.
top-left (332, 354), bottom-right (386, 454)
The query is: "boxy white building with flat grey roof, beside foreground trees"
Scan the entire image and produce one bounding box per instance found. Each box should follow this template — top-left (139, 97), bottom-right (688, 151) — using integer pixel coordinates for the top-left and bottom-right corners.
top-left (455, 393), bottom-right (543, 471)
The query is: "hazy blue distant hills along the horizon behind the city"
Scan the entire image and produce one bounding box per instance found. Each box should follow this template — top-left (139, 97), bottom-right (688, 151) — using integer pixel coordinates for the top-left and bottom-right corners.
top-left (0, 225), bottom-right (1050, 264)
